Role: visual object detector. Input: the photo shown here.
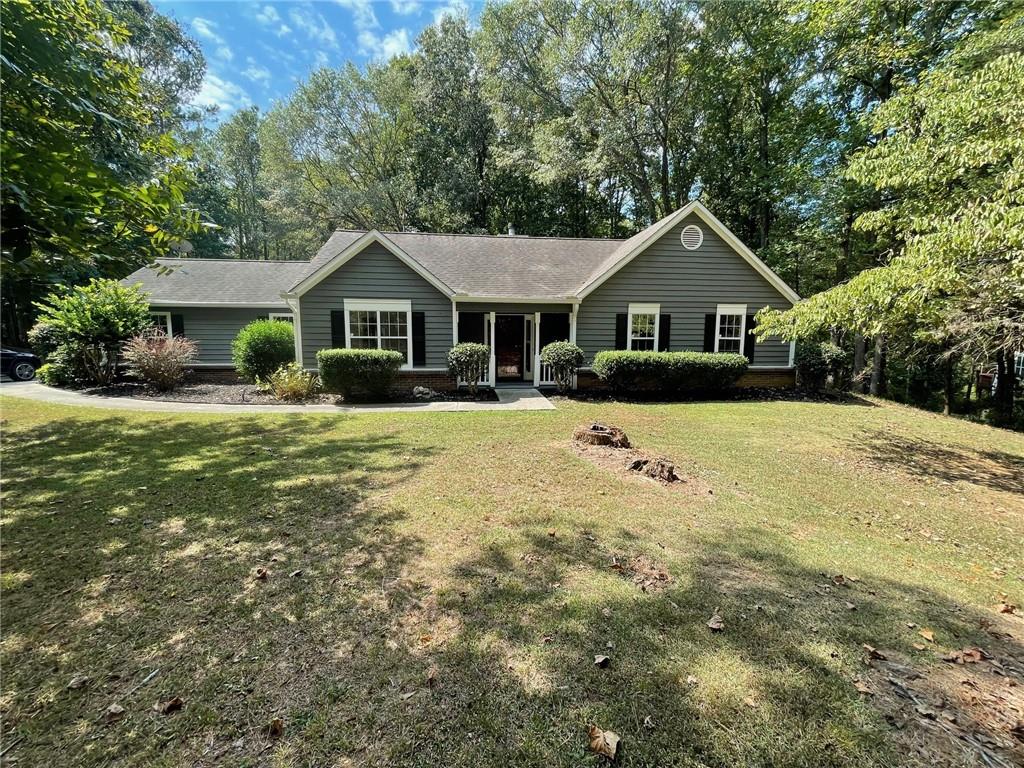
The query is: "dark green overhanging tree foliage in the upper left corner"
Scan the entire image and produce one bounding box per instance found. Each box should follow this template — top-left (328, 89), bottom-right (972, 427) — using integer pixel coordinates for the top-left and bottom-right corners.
top-left (0, 0), bottom-right (199, 279)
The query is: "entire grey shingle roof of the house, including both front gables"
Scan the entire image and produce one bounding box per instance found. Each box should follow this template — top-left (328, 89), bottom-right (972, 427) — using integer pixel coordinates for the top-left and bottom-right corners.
top-left (122, 201), bottom-right (800, 307)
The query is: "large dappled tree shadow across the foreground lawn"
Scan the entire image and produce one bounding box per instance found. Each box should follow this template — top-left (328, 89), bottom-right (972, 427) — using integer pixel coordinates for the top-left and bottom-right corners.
top-left (4, 417), bottom-right (1022, 768)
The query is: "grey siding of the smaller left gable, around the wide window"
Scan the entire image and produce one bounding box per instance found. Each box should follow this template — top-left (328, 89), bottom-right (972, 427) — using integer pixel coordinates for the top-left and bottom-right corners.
top-left (299, 243), bottom-right (452, 368)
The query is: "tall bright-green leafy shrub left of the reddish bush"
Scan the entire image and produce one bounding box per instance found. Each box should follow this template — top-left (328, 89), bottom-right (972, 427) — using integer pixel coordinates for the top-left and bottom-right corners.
top-left (36, 279), bottom-right (150, 385)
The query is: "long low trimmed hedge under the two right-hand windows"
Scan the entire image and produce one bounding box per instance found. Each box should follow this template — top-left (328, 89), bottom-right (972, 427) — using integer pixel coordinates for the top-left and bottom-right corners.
top-left (593, 351), bottom-right (748, 394)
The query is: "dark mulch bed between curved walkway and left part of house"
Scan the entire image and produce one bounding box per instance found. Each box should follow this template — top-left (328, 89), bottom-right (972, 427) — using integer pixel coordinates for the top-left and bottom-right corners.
top-left (80, 382), bottom-right (498, 406)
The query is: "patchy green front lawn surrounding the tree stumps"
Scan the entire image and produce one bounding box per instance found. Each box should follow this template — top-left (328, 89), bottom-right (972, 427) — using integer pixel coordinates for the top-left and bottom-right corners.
top-left (0, 397), bottom-right (1024, 767)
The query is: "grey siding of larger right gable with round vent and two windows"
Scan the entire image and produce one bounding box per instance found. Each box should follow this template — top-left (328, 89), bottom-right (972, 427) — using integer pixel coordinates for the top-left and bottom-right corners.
top-left (577, 215), bottom-right (792, 367)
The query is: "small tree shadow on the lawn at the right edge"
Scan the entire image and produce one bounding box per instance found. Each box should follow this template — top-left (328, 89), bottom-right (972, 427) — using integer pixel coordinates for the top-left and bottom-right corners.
top-left (849, 430), bottom-right (1024, 494)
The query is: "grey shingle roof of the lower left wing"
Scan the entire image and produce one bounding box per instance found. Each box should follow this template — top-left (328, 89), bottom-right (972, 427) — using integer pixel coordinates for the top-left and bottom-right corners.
top-left (121, 259), bottom-right (309, 307)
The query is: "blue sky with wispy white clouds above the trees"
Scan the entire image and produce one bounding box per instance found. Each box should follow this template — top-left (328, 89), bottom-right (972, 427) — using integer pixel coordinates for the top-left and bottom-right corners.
top-left (154, 0), bottom-right (480, 119)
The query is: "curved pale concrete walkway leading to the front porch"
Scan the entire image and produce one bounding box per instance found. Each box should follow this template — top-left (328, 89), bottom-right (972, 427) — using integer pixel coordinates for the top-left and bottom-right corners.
top-left (0, 381), bottom-right (555, 414)
